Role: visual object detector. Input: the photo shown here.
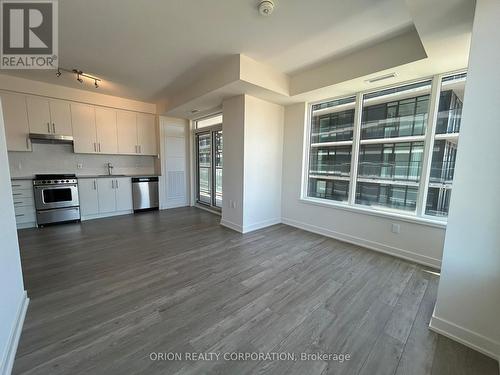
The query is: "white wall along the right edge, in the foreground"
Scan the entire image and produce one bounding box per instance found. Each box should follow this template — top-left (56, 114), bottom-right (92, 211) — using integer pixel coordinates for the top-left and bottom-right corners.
top-left (431, 0), bottom-right (500, 359)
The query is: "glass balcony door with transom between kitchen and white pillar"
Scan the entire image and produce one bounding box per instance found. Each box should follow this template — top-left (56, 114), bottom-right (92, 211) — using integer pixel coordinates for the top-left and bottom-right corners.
top-left (195, 116), bottom-right (223, 210)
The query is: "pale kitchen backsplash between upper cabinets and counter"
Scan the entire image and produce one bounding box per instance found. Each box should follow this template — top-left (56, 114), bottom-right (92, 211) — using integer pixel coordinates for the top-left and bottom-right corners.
top-left (9, 143), bottom-right (156, 177)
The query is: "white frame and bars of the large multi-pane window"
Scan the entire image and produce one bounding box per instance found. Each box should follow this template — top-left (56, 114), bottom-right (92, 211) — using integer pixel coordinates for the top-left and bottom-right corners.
top-left (299, 68), bottom-right (467, 228)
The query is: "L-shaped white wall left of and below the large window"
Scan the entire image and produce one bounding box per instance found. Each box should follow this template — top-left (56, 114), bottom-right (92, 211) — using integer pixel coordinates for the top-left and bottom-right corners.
top-left (282, 103), bottom-right (445, 267)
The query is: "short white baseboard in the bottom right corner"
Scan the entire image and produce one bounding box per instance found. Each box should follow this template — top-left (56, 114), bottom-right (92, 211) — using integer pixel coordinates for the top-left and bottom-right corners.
top-left (429, 313), bottom-right (500, 361)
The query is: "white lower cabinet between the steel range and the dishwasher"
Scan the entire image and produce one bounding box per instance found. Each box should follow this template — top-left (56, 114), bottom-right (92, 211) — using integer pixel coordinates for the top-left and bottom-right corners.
top-left (78, 177), bottom-right (132, 220)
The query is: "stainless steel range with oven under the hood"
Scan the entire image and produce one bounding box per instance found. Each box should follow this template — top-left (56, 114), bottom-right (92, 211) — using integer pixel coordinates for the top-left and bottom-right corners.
top-left (33, 174), bottom-right (80, 227)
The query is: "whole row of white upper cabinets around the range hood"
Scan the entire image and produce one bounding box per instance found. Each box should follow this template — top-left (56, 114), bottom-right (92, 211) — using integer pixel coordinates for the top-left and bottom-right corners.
top-left (4, 92), bottom-right (158, 156)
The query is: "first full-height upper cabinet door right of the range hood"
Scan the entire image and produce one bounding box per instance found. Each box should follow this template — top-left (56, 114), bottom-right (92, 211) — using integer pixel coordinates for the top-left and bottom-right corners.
top-left (71, 103), bottom-right (97, 154)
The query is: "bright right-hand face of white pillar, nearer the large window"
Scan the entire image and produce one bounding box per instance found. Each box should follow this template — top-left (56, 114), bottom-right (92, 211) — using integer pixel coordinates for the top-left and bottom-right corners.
top-left (243, 95), bottom-right (284, 232)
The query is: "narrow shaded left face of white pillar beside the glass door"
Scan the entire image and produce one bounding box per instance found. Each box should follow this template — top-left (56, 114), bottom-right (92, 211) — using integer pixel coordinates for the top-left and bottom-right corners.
top-left (221, 95), bottom-right (245, 232)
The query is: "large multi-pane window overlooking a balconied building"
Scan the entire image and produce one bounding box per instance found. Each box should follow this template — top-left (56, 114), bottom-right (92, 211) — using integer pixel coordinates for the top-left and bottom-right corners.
top-left (305, 73), bottom-right (466, 222)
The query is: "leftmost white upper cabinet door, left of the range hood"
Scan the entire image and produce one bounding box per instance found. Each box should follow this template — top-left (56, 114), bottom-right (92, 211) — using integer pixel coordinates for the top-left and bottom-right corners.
top-left (1, 93), bottom-right (31, 151)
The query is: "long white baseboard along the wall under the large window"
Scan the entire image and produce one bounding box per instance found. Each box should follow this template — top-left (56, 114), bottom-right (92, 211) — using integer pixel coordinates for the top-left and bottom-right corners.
top-left (281, 218), bottom-right (441, 269)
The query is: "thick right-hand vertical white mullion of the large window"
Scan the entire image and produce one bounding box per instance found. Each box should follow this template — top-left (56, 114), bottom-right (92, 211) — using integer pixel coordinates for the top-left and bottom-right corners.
top-left (417, 75), bottom-right (442, 216)
